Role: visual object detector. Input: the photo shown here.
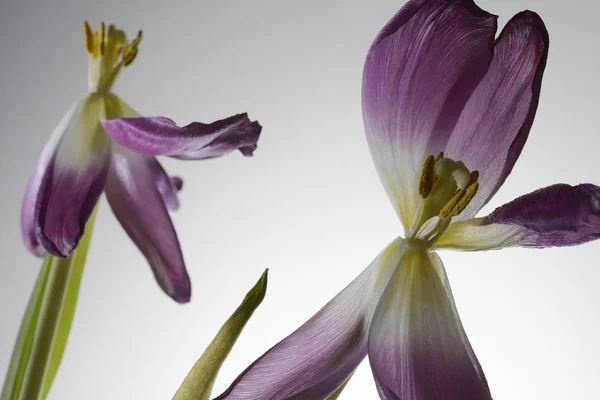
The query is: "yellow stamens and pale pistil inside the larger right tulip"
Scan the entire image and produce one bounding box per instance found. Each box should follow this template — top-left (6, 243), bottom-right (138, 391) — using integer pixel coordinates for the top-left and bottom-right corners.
top-left (407, 153), bottom-right (479, 248)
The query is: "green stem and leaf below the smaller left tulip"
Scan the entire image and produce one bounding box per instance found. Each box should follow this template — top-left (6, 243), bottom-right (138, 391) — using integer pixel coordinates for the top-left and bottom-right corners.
top-left (0, 207), bottom-right (97, 400)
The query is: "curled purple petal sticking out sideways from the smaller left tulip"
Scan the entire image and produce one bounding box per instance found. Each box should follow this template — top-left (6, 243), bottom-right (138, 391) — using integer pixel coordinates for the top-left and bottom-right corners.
top-left (104, 114), bottom-right (262, 160)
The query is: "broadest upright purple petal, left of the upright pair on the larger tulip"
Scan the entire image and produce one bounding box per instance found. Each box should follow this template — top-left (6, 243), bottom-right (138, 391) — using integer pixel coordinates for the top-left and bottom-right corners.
top-left (362, 0), bottom-right (496, 229)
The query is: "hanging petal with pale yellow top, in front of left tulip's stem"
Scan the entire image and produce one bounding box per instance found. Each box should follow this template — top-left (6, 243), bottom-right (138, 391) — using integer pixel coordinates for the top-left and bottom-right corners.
top-left (34, 95), bottom-right (110, 257)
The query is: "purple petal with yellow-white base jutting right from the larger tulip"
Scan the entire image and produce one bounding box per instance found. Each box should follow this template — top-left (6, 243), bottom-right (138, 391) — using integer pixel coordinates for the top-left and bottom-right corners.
top-left (437, 183), bottom-right (600, 250)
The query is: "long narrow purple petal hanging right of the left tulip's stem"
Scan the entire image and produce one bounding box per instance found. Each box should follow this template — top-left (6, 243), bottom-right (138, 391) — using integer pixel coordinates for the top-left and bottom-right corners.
top-left (106, 145), bottom-right (191, 303)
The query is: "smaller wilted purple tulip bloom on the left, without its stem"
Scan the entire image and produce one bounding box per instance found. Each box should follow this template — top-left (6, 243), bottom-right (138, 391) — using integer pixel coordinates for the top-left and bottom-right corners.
top-left (21, 22), bottom-right (261, 302)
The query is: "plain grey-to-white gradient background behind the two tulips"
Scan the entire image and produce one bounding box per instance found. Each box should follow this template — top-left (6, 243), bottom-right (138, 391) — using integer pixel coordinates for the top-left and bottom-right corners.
top-left (0, 0), bottom-right (600, 400)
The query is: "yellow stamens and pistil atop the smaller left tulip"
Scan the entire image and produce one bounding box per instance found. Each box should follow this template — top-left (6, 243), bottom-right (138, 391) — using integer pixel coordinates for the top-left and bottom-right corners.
top-left (83, 21), bottom-right (142, 94)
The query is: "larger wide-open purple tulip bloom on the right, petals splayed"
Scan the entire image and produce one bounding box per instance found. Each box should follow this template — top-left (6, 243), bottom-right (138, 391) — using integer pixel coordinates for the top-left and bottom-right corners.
top-left (218, 0), bottom-right (600, 400)
